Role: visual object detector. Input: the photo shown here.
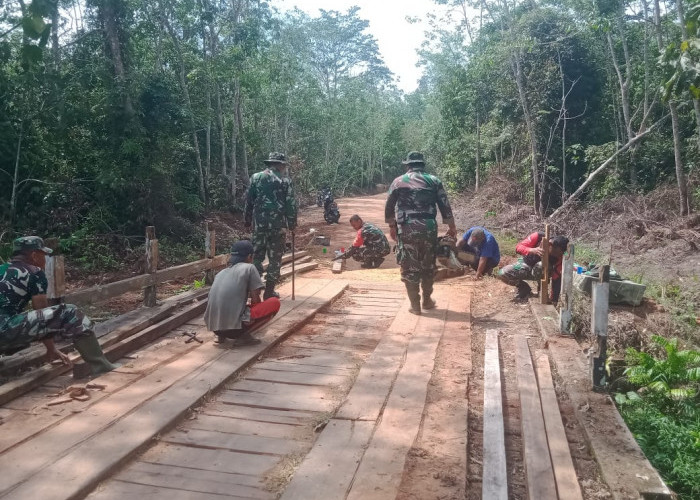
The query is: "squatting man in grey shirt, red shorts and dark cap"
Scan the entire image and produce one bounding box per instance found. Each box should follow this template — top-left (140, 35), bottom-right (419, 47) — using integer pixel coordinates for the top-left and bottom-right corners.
top-left (204, 240), bottom-right (280, 345)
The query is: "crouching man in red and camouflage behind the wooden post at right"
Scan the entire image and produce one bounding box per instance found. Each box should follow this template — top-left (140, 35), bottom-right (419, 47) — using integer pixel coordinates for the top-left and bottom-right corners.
top-left (498, 232), bottom-right (569, 303)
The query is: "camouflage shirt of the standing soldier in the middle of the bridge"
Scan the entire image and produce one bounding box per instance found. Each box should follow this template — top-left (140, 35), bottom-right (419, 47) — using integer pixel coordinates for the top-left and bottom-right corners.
top-left (384, 167), bottom-right (454, 225)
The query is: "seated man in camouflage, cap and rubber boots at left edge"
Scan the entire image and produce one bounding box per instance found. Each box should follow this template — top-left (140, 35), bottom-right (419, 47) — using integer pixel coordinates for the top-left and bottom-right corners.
top-left (0, 236), bottom-right (116, 375)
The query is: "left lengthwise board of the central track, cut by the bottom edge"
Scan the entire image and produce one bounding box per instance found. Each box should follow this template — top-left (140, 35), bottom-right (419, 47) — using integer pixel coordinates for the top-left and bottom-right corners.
top-left (280, 419), bottom-right (374, 500)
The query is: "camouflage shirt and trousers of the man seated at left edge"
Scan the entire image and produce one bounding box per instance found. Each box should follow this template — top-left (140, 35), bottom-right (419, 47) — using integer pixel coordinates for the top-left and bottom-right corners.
top-left (0, 257), bottom-right (93, 351)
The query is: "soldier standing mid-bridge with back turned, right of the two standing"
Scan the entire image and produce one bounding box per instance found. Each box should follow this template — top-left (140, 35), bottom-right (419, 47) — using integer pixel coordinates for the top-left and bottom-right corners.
top-left (384, 151), bottom-right (457, 314)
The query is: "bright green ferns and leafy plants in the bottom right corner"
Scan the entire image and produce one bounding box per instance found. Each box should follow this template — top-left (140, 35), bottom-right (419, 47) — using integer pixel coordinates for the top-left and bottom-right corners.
top-left (615, 335), bottom-right (700, 500)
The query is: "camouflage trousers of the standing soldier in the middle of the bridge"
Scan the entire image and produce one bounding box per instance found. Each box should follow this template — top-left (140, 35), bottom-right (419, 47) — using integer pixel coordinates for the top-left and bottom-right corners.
top-left (396, 219), bottom-right (437, 283)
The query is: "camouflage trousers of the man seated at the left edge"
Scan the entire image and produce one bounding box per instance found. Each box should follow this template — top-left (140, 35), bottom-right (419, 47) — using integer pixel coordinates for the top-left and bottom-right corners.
top-left (0, 304), bottom-right (93, 349)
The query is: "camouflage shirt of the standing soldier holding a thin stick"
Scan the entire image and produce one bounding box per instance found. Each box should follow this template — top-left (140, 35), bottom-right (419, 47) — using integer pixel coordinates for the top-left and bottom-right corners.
top-left (245, 168), bottom-right (297, 229)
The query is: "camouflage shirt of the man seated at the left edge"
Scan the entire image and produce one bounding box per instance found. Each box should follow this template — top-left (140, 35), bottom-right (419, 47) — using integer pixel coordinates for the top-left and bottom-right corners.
top-left (0, 259), bottom-right (49, 316)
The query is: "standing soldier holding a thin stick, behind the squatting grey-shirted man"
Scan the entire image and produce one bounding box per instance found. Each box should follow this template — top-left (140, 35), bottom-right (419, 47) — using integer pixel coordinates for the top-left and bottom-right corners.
top-left (245, 153), bottom-right (297, 299)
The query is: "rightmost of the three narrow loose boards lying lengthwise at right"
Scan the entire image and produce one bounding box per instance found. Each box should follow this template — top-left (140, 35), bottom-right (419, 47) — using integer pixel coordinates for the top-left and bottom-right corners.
top-left (535, 351), bottom-right (583, 500)
